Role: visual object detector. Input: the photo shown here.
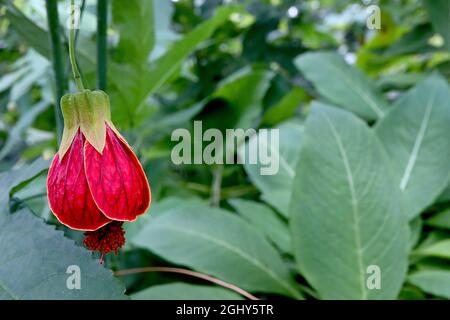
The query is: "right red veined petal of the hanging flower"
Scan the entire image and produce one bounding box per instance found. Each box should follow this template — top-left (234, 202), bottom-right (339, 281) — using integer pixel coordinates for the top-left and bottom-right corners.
top-left (84, 126), bottom-right (150, 221)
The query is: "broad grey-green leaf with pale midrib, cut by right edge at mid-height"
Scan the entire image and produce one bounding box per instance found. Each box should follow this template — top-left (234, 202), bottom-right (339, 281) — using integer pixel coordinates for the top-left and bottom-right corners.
top-left (376, 75), bottom-right (450, 218)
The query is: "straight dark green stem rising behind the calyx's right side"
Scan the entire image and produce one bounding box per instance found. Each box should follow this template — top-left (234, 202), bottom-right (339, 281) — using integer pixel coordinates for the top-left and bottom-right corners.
top-left (97, 0), bottom-right (108, 91)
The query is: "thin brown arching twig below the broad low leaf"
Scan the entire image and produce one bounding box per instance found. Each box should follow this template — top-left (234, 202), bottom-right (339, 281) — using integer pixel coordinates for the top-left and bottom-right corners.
top-left (114, 267), bottom-right (259, 300)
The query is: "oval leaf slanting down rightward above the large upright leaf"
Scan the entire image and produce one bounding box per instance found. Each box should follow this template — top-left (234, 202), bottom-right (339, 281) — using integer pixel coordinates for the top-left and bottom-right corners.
top-left (295, 52), bottom-right (388, 120)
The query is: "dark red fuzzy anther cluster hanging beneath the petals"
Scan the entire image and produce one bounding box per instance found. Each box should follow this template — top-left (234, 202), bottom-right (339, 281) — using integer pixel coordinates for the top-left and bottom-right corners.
top-left (84, 221), bottom-right (125, 255)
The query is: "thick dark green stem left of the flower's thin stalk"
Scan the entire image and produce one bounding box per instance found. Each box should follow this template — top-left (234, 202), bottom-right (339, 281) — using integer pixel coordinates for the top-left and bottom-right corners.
top-left (45, 0), bottom-right (66, 144)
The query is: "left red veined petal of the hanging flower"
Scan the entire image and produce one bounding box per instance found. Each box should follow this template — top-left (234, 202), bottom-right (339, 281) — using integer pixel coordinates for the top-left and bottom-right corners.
top-left (47, 131), bottom-right (111, 231)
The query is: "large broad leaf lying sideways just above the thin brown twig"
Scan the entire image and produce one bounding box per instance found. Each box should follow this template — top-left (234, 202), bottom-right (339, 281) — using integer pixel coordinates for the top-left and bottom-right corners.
top-left (131, 206), bottom-right (300, 298)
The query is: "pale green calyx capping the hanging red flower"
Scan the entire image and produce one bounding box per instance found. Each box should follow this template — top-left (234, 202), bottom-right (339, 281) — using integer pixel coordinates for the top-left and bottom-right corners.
top-left (58, 90), bottom-right (115, 159)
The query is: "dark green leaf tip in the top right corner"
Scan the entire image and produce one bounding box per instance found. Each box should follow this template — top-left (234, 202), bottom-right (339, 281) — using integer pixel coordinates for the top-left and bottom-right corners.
top-left (423, 0), bottom-right (450, 50)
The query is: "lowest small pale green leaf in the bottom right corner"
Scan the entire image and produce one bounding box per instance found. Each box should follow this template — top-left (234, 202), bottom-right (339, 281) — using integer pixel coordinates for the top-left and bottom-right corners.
top-left (408, 270), bottom-right (450, 299)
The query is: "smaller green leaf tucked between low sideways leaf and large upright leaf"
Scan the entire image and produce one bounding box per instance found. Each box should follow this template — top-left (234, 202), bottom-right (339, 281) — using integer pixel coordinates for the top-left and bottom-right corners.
top-left (228, 199), bottom-right (292, 253)
